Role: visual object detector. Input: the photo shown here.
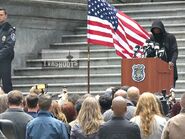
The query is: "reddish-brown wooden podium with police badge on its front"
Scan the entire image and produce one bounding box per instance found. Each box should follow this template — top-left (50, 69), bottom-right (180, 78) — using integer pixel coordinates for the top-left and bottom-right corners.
top-left (121, 58), bottom-right (174, 94)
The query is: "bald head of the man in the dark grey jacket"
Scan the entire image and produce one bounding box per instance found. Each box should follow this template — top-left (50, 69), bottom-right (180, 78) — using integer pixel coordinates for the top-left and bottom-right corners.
top-left (112, 96), bottom-right (127, 117)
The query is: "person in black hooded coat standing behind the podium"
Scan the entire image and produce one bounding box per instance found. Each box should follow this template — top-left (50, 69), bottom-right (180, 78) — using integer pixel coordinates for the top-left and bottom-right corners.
top-left (150, 20), bottom-right (178, 87)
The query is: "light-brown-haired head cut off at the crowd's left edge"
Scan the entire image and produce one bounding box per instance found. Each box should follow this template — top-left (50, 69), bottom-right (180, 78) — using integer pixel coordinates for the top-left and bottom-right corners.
top-left (0, 94), bottom-right (8, 113)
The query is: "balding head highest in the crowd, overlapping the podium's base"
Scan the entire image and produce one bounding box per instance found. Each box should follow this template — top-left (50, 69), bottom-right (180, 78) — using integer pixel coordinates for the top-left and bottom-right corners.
top-left (127, 86), bottom-right (140, 106)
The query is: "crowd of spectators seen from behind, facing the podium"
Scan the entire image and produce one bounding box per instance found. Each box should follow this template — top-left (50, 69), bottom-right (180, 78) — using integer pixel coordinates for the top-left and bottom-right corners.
top-left (0, 85), bottom-right (185, 139)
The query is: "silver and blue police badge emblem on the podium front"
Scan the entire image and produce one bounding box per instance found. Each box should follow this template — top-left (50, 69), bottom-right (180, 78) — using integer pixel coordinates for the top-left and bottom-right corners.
top-left (132, 64), bottom-right (145, 82)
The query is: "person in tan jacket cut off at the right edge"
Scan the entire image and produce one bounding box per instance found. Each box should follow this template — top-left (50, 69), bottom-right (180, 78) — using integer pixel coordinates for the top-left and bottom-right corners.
top-left (161, 93), bottom-right (185, 139)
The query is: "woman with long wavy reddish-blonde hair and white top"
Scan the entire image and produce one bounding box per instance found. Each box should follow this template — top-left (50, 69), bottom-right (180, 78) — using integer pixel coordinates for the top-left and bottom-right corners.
top-left (130, 92), bottom-right (166, 139)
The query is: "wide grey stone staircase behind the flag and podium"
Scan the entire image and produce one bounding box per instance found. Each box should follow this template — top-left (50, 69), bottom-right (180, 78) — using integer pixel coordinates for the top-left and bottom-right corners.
top-left (13, 1), bottom-right (185, 95)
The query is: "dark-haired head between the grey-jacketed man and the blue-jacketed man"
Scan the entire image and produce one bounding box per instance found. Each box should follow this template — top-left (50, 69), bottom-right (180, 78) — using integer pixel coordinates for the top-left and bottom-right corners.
top-left (26, 93), bottom-right (39, 109)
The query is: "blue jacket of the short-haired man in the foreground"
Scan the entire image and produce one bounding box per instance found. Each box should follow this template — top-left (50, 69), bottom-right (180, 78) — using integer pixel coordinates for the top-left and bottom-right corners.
top-left (26, 111), bottom-right (68, 139)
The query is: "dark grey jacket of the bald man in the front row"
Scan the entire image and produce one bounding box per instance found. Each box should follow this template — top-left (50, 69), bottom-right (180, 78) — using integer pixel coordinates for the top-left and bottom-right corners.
top-left (99, 117), bottom-right (141, 139)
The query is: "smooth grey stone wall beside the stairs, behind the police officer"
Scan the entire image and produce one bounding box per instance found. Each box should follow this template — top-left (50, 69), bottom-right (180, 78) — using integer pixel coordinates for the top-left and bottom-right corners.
top-left (1, 0), bottom-right (87, 68)
